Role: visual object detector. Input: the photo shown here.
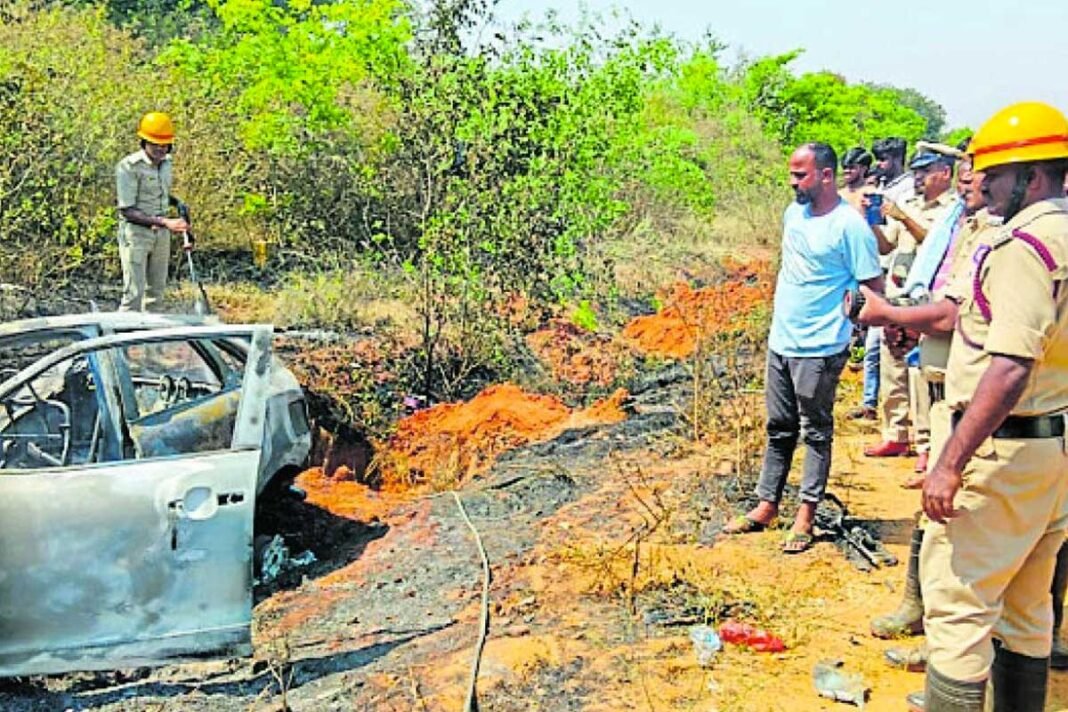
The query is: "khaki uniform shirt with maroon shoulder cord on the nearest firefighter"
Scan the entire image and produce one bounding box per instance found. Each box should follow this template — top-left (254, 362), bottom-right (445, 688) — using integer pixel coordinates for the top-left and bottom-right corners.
top-left (946, 199), bottom-right (1068, 415)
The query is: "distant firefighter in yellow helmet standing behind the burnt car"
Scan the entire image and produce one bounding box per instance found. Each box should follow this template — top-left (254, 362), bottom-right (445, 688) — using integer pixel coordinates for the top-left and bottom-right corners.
top-left (115, 111), bottom-right (189, 311)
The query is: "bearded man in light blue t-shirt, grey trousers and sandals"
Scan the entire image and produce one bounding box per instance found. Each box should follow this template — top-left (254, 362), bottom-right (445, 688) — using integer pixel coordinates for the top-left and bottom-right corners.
top-left (725, 143), bottom-right (882, 553)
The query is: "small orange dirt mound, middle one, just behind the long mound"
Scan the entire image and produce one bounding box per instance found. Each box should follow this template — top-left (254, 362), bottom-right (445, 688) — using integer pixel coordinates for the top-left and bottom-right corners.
top-left (527, 319), bottom-right (626, 385)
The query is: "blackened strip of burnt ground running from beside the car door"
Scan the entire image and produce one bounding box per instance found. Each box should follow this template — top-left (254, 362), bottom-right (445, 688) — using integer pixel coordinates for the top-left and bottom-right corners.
top-left (0, 367), bottom-right (688, 710)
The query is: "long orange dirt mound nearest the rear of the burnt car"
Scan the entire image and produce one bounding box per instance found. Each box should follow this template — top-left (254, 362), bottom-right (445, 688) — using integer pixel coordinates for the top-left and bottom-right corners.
top-left (379, 383), bottom-right (627, 487)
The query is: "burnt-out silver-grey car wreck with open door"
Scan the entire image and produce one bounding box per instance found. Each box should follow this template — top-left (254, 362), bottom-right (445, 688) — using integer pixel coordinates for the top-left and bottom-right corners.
top-left (0, 313), bottom-right (311, 676)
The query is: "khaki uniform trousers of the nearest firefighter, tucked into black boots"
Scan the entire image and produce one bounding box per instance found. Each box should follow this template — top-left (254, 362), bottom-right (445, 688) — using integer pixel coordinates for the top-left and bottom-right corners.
top-left (920, 429), bottom-right (1068, 682)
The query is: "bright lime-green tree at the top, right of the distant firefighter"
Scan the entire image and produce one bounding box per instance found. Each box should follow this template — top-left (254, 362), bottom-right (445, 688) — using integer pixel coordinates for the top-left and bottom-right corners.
top-left (160, 0), bottom-right (411, 155)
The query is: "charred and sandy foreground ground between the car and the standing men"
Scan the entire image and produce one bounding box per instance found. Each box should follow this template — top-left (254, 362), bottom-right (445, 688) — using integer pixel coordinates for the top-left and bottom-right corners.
top-left (6, 286), bottom-right (1068, 712)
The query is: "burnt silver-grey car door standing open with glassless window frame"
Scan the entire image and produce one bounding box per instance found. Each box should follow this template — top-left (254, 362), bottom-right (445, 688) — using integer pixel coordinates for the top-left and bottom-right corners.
top-left (0, 327), bottom-right (271, 676)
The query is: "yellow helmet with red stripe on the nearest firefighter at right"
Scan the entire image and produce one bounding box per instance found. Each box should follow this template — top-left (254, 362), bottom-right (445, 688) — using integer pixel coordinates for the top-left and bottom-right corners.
top-left (968, 101), bottom-right (1068, 171)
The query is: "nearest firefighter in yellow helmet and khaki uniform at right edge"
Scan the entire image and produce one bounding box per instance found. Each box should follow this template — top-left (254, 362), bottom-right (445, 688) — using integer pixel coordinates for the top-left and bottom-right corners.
top-left (860, 102), bottom-right (1068, 712)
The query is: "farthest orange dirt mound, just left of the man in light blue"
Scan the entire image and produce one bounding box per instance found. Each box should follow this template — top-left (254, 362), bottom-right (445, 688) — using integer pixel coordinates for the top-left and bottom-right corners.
top-left (623, 262), bottom-right (771, 359)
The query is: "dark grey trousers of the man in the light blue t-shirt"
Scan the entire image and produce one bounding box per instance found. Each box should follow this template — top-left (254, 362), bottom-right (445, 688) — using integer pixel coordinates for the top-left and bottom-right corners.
top-left (756, 349), bottom-right (849, 504)
